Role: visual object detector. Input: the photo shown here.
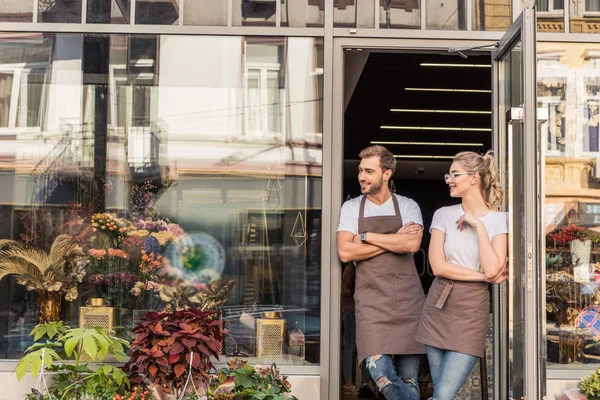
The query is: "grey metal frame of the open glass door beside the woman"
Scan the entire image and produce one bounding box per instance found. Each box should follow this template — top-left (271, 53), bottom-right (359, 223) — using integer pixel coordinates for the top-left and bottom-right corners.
top-left (492, 7), bottom-right (546, 400)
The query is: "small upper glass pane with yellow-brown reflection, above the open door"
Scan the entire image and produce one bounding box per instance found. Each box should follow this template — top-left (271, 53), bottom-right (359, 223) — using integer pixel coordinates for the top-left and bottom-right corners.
top-left (471, 0), bottom-right (512, 32)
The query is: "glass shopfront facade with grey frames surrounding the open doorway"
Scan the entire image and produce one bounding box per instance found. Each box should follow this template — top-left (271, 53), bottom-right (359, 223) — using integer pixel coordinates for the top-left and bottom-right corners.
top-left (0, 0), bottom-right (600, 400)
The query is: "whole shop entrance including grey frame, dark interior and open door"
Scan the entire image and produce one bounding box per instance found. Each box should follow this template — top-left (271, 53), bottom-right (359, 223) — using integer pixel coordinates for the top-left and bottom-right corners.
top-left (322, 8), bottom-right (546, 400)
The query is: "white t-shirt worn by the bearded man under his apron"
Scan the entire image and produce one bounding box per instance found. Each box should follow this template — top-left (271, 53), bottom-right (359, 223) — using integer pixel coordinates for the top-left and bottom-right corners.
top-left (338, 194), bottom-right (423, 235)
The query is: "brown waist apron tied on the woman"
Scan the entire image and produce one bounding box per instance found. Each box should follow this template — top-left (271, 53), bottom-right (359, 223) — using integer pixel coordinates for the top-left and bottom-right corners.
top-left (417, 277), bottom-right (490, 357)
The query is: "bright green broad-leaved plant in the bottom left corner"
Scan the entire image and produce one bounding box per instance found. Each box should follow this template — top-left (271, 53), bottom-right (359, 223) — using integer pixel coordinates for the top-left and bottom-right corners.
top-left (16, 321), bottom-right (129, 400)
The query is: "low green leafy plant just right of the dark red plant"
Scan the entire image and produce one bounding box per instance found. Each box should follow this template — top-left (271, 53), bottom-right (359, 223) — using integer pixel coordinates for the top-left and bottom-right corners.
top-left (200, 358), bottom-right (296, 400)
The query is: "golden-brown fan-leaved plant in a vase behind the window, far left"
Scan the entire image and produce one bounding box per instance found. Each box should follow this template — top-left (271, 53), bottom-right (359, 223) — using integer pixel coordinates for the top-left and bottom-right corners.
top-left (0, 235), bottom-right (88, 324)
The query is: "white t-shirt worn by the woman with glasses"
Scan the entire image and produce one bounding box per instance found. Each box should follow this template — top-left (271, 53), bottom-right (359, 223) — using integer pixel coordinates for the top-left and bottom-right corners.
top-left (429, 204), bottom-right (508, 271)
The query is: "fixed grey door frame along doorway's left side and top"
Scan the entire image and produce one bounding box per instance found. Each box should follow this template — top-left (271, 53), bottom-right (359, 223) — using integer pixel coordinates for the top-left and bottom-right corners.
top-left (328, 37), bottom-right (510, 400)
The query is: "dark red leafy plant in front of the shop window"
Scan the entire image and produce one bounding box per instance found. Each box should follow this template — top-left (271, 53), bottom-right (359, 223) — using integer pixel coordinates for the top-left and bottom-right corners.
top-left (123, 309), bottom-right (225, 396)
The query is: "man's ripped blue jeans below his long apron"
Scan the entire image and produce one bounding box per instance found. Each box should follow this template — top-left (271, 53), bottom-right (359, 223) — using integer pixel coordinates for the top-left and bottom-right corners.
top-left (365, 354), bottom-right (421, 400)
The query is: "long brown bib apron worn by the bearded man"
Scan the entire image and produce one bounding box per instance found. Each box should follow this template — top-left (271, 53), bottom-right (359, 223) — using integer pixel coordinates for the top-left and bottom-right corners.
top-left (354, 194), bottom-right (425, 360)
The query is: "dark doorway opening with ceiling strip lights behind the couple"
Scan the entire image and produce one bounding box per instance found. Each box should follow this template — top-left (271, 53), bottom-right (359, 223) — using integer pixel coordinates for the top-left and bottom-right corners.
top-left (341, 48), bottom-right (492, 400)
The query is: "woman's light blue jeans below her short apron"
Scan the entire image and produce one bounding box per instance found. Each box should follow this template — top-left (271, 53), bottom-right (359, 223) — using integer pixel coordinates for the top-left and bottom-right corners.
top-left (425, 346), bottom-right (479, 400)
